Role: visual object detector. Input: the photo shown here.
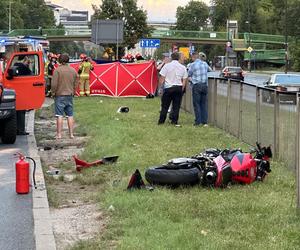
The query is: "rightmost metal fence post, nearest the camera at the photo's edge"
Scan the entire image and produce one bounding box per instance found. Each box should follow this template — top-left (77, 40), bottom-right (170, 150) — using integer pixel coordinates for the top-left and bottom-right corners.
top-left (295, 93), bottom-right (300, 210)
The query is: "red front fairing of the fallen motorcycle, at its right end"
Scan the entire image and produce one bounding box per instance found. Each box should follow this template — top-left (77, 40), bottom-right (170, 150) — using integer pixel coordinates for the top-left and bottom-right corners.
top-left (230, 153), bottom-right (257, 184)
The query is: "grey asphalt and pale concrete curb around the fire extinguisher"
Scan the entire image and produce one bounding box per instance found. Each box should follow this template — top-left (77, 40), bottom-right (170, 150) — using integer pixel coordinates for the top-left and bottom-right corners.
top-left (0, 111), bottom-right (56, 250)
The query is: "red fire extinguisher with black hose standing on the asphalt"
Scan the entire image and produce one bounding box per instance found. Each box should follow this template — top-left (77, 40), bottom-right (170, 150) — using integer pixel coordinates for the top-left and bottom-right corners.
top-left (16, 153), bottom-right (36, 194)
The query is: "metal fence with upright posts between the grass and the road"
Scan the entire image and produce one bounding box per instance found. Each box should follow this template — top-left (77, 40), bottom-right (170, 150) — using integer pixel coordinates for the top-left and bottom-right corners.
top-left (182, 78), bottom-right (300, 208)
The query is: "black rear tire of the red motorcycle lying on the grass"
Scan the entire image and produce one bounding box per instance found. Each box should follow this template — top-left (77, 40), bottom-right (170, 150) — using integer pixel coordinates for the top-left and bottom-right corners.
top-left (145, 167), bottom-right (200, 186)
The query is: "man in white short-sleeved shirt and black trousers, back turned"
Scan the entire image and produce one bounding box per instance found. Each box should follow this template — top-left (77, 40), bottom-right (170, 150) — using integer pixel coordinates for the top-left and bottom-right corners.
top-left (158, 52), bottom-right (188, 125)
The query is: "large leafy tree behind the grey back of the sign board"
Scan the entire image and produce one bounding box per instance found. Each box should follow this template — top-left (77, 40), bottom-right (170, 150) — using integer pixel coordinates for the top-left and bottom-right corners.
top-left (92, 0), bottom-right (151, 54)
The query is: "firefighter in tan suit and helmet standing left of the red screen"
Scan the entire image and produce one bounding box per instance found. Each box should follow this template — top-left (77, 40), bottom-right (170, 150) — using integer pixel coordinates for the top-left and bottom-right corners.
top-left (78, 54), bottom-right (94, 96)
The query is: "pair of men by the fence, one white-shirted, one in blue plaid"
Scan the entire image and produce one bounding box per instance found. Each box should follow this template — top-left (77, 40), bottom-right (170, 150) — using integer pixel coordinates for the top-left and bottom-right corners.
top-left (158, 52), bottom-right (212, 126)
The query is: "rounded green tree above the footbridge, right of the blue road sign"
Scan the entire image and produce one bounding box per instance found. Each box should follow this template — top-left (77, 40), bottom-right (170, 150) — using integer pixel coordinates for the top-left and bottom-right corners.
top-left (176, 1), bottom-right (209, 30)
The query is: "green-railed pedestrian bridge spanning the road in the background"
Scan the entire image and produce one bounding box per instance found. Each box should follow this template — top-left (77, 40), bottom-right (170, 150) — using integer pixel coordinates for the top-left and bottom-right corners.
top-left (0, 29), bottom-right (285, 64)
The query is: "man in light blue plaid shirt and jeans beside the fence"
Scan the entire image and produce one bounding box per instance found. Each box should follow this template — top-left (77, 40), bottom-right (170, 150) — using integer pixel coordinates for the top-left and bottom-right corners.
top-left (188, 52), bottom-right (212, 127)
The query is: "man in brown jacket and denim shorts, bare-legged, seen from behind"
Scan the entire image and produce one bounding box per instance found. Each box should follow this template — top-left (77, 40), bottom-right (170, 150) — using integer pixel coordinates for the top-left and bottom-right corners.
top-left (51, 54), bottom-right (79, 139)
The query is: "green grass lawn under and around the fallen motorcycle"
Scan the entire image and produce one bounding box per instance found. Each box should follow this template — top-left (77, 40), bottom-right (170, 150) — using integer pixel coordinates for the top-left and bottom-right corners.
top-left (72, 97), bottom-right (300, 250)
